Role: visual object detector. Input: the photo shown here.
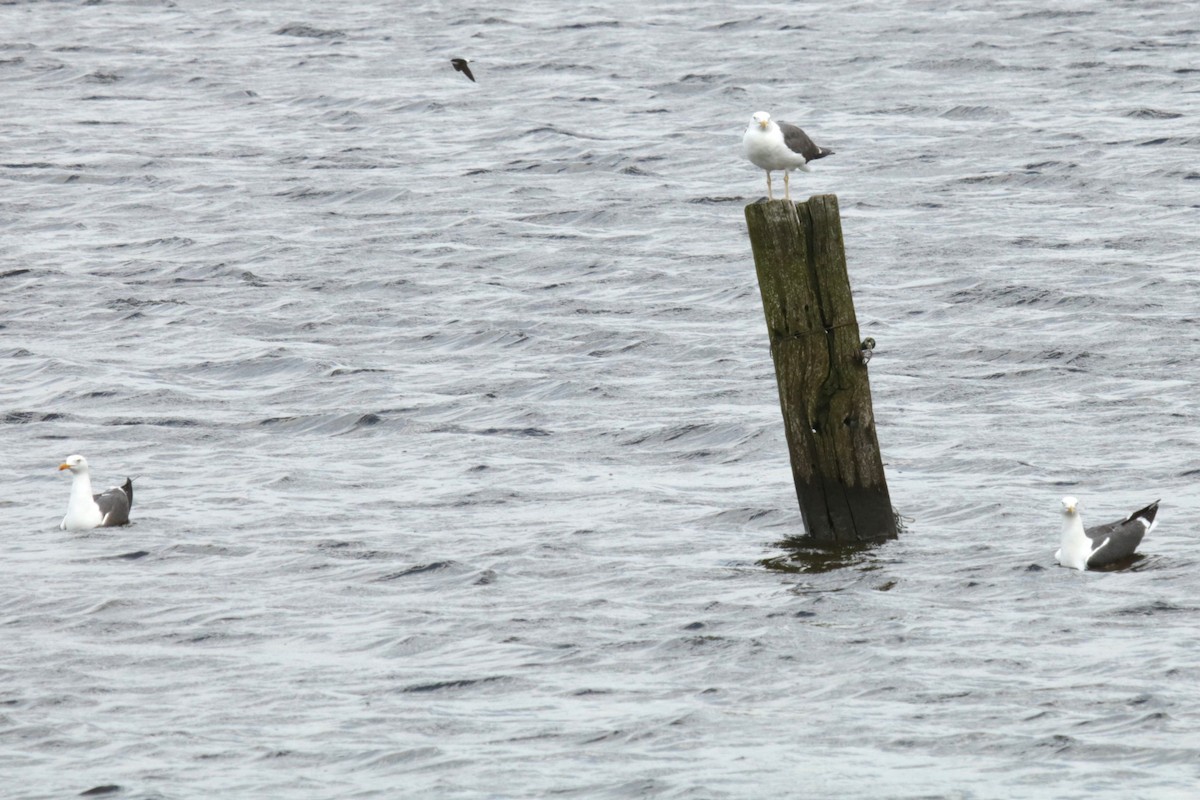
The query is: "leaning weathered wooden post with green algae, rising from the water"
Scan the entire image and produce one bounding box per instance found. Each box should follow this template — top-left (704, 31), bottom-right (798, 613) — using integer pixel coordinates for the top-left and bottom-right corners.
top-left (745, 194), bottom-right (896, 546)
